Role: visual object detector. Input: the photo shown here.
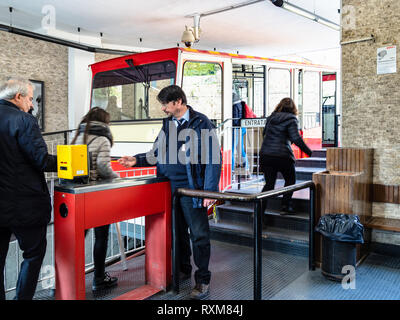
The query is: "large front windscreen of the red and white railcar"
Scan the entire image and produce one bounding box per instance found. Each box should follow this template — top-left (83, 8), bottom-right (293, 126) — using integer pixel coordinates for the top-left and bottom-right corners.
top-left (91, 61), bottom-right (176, 121)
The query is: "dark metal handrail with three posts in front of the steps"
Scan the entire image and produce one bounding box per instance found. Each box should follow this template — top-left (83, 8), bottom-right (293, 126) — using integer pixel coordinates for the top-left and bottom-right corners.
top-left (172, 181), bottom-right (315, 300)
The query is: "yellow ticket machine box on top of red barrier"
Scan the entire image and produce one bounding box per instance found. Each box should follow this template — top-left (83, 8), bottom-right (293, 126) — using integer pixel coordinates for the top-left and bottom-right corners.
top-left (57, 144), bottom-right (89, 180)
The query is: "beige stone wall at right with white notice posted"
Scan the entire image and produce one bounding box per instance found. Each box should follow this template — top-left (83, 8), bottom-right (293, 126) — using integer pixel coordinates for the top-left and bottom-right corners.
top-left (342, 0), bottom-right (400, 219)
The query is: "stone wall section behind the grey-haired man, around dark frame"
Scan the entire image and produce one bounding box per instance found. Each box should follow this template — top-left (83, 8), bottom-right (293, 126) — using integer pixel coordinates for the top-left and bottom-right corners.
top-left (0, 31), bottom-right (68, 132)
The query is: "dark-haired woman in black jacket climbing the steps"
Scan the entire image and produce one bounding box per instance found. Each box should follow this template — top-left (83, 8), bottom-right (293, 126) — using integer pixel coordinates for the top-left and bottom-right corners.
top-left (260, 98), bottom-right (312, 214)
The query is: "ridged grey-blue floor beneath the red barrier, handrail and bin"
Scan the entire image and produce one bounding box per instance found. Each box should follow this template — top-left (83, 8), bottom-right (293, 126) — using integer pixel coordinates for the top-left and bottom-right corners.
top-left (35, 240), bottom-right (400, 300)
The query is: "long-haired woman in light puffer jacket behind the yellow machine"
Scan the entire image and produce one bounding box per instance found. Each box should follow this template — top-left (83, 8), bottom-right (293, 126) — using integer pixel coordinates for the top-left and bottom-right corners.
top-left (71, 107), bottom-right (118, 292)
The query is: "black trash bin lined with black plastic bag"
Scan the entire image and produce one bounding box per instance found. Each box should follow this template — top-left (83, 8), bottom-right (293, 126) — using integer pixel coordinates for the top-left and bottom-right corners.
top-left (315, 214), bottom-right (364, 281)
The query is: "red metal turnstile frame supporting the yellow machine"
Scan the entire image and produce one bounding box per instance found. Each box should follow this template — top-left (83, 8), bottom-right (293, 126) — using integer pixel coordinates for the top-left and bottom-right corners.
top-left (54, 178), bottom-right (171, 300)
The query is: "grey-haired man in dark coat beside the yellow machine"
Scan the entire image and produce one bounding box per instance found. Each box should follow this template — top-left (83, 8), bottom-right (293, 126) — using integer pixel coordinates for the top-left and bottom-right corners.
top-left (0, 79), bottom-right (57, 300)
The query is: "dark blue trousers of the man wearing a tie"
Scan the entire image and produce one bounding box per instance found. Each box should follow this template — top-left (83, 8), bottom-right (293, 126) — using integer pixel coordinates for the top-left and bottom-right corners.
top-left (177, 197), bottom-right (211, 284)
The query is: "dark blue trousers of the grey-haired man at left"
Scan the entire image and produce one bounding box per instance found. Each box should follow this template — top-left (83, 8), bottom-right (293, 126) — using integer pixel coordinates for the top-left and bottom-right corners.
top-left (0, 226), bottom-right (47, 300)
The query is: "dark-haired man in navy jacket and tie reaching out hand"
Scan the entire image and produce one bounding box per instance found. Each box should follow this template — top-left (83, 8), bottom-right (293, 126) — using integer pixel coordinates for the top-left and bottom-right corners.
top-left (119, 85), bottom-right (221, 299)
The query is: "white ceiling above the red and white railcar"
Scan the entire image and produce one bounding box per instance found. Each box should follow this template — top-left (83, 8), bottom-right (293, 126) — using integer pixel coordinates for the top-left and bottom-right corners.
top-left (0, 0), bottom-right (340, 65)
